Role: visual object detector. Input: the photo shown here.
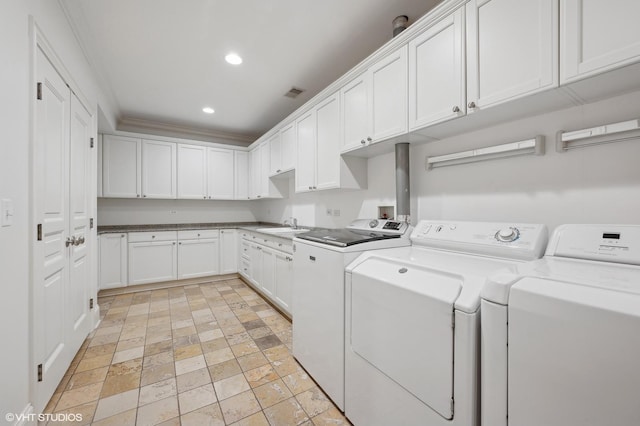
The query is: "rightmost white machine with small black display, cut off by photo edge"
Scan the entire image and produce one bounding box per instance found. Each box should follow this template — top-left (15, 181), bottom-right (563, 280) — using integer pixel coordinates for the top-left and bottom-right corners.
top-left (481, 225), bottom-right (640, 426)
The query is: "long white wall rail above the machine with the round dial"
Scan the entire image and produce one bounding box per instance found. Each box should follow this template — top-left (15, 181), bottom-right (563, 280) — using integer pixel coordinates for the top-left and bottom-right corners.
top-left (426, 136), bottom-right (544, 170)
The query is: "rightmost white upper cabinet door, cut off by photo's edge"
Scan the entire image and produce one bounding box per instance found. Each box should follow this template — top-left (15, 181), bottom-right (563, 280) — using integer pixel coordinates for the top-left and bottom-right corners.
top-left (560, 0), bottom-right (640, 84)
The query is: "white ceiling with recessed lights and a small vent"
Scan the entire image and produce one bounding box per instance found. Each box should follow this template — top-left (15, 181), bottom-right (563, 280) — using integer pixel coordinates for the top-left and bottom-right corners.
top-left (61, 0), bottom-right (439, 143)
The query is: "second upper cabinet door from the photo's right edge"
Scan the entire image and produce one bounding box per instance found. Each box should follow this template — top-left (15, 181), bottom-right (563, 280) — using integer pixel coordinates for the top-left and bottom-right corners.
top-left (467, 0), bottom-right (558, 113)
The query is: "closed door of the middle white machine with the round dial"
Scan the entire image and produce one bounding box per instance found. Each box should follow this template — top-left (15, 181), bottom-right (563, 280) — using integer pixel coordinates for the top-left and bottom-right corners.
top-left (347, 257), bottom-right (462, 419)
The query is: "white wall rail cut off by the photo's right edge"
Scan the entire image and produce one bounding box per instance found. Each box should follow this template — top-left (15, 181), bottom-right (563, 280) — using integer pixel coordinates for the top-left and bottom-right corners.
top-left (556, 119), bottom-right (640, 152)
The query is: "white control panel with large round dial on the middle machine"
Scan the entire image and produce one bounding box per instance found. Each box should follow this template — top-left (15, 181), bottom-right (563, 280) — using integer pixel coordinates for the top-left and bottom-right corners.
top-left (411, 220), bottom-right (548, 260)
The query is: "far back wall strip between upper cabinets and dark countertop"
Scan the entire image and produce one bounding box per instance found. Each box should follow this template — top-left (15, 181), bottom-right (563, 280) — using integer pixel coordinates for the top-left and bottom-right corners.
top-left (97, 198), bottom-right (256, 226)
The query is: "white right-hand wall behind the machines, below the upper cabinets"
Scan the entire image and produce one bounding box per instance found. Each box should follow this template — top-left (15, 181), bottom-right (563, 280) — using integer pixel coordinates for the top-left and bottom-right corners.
top-left (256, 92), bottom-right (640, 233)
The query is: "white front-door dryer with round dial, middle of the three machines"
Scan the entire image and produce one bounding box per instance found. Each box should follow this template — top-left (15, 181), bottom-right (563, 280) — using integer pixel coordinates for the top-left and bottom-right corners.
top-left (345, 221), bottom-right (547, 426)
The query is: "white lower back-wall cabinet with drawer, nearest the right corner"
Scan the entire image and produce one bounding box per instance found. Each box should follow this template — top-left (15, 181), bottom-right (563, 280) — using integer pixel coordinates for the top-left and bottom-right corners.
top-left (178, 229), bottom-right (220, 279)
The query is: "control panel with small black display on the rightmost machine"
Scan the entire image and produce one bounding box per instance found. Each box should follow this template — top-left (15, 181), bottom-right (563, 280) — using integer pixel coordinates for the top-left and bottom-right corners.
top-left (546, 225), bottom-right (640, 265)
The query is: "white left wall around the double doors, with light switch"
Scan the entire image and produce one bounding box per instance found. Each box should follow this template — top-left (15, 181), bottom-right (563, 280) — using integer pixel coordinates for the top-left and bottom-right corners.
top-left (0, 0), bottom-right (112, 420)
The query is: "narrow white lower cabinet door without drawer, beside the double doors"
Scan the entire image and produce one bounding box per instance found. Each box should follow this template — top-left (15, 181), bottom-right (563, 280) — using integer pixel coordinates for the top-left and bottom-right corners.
top-left (98, 234), bottom-right (127, 290)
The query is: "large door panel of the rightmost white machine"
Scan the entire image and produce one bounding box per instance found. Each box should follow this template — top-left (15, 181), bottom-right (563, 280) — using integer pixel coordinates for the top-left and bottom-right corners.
top-left (508, 278), bottom-right (640, 426)
